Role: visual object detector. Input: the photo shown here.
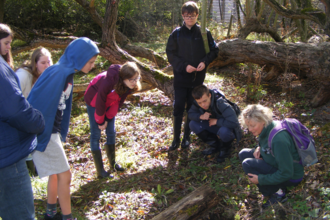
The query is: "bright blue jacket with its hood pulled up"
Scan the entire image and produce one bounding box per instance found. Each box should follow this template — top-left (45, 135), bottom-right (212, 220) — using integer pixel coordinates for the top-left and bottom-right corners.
top-left (28, 37), bottom-right (100, 152)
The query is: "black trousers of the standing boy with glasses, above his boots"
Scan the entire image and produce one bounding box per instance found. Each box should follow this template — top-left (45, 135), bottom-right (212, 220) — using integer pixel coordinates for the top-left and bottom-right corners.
top-left (173, 87), bottom-right (194, 117)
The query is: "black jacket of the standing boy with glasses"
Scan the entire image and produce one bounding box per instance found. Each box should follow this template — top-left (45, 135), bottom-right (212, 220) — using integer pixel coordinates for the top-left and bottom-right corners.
top-left (166, 24), bottom-right (219, 88)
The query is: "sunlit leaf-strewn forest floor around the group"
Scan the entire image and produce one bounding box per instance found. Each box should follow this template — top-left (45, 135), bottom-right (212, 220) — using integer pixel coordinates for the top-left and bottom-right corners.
top-left (27, 64), bottom-right (330, 219)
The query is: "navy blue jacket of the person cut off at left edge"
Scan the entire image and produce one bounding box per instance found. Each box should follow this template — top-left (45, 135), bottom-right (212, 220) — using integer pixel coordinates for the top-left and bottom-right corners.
top-left (0, 56), bottom-right (45, 169)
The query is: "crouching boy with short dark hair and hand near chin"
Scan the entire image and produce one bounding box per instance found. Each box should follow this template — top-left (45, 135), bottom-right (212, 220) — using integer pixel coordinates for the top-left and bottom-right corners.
top-left (188, 85), bottom-right (241, 163)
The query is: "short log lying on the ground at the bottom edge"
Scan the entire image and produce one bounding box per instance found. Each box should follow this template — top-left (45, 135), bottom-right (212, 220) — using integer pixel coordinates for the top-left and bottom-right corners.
top-left (152, 185), bottom-right (219, 220)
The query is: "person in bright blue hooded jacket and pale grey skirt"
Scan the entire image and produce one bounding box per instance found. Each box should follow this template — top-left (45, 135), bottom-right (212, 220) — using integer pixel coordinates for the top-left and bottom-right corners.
top-left (28, 37), bottom-right (100, 220)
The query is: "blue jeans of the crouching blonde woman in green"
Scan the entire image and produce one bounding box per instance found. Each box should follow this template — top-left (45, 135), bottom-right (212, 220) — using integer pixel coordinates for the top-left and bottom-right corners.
top-left (238, 148), bottom-right (300, 196)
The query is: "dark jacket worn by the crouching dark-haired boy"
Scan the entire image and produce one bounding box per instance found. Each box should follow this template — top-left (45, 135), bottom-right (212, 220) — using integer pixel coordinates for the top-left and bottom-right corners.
top-left (188, 89), bottom-right (242, 142)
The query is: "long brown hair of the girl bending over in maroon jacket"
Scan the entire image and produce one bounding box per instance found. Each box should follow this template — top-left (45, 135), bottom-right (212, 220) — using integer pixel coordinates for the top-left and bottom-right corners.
top-left (115, 62), bottom-right (141, 96)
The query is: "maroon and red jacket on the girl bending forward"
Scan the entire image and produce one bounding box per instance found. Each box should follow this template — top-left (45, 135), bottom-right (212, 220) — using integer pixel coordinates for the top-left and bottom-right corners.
top-left (84, 65), bottom-right (131, 125)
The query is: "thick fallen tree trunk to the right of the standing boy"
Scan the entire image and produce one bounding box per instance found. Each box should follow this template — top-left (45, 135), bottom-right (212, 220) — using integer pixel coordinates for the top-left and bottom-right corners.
top-left (210, 39), bottom-right (330, 107)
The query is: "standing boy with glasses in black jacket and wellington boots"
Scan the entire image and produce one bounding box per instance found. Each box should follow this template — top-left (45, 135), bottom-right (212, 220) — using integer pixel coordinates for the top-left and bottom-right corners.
top-left (166, 1), bottom-right (219, 150)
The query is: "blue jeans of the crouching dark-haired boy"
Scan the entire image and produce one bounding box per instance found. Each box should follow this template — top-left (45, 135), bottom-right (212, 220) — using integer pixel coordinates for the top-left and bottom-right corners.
top-left (189, 120), bottom-right (235, 142)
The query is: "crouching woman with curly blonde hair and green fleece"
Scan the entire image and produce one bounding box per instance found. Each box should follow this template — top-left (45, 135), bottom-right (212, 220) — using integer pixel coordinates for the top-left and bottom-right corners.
top-left (239, 105), bottom-right (304, 208)
